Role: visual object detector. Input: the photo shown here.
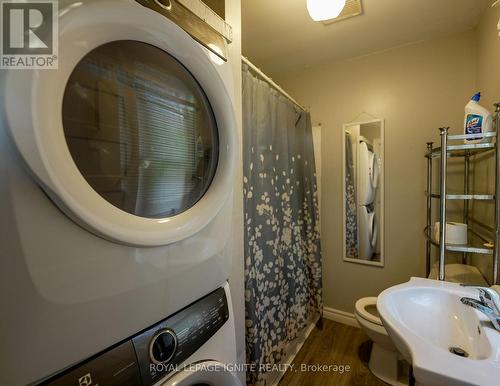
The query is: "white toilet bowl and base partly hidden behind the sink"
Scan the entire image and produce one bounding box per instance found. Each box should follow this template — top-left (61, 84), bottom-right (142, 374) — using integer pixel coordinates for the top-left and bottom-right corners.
top-left (354, 297), bottom-right (409, 386)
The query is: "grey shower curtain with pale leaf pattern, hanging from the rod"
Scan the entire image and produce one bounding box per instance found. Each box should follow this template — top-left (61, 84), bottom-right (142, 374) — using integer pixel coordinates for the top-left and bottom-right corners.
top-left (243, 64), bottom-right (323, 385)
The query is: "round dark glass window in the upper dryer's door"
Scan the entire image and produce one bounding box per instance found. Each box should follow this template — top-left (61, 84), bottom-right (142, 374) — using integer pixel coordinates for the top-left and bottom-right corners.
top-left (62, 40), bottom-right (219, 219)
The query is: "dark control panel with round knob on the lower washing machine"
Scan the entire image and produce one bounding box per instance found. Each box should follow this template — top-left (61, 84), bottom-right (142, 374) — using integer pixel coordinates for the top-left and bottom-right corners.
top-left (40, 288), bottom-right (229, 386)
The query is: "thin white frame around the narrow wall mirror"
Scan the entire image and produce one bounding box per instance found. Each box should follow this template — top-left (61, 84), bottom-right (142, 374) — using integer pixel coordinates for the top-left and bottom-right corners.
top-left (341, 119), bottom-right (385, 267)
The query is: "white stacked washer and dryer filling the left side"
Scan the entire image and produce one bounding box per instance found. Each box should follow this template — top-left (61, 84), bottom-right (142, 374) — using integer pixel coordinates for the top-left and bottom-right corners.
top-left (0, 0), bottom-right (240, 386)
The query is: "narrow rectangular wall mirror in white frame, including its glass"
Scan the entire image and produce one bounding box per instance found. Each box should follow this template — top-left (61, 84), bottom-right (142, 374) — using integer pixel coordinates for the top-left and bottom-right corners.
top-left (342, 119), bottom-right (384, 267)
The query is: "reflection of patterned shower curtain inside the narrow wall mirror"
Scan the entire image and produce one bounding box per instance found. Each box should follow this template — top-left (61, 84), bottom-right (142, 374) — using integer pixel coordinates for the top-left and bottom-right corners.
top-left (345, 132), bottom-right (359, 259)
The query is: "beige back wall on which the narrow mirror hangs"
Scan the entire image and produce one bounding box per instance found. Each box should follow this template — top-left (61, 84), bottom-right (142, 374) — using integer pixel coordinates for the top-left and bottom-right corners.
top-left (278, 31), bottom-right (476, 312)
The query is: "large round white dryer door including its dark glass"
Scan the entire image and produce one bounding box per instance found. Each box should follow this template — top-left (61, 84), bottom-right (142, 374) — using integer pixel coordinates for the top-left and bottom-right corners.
top-left (5, 0), bottom-right (237, 246)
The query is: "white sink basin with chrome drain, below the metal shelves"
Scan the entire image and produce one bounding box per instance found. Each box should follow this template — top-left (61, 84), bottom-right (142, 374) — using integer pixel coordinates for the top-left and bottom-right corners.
top-left (377, 278), bottom-right (500, 386)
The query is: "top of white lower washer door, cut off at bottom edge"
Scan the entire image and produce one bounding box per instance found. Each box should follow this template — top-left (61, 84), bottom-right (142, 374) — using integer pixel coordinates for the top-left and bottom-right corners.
top-left (157, 361), bottom-right (241, 386)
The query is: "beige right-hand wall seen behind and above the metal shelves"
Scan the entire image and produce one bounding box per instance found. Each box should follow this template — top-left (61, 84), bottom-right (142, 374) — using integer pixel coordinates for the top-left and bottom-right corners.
top-left (472, 3), bottom-right (500, 281)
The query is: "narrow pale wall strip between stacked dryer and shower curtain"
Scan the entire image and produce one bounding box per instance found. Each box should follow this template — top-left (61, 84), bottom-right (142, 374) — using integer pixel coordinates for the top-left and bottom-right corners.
top-left (225, 0), bottom-right (245, 384)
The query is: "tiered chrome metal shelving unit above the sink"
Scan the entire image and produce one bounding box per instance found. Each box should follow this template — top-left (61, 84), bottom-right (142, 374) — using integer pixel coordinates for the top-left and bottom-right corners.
top-left (425, 103), bottom-right (500, 284)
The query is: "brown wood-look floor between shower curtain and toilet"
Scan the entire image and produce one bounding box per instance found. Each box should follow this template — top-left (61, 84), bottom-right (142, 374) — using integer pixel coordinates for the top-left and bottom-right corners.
top-left (279, 319), bottom-right (386, 386)
